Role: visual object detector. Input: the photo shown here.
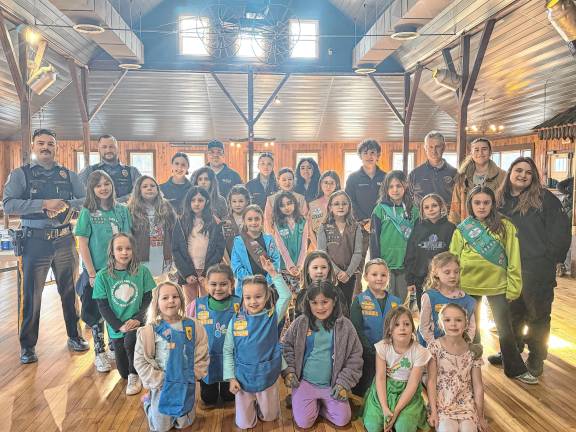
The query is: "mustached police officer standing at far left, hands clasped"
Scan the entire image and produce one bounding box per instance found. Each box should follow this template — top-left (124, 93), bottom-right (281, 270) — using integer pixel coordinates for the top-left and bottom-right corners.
top-left (3, 129), bottom-right (88, 364)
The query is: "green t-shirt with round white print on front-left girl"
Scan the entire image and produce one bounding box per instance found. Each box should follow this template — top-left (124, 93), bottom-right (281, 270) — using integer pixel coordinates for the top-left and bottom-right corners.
top-left (92, 265), bottom-right (156, 339)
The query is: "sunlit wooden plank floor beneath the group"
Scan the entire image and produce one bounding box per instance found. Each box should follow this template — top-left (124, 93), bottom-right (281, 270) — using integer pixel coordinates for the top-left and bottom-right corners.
top-left (0, 272), bottom-right (576, 432)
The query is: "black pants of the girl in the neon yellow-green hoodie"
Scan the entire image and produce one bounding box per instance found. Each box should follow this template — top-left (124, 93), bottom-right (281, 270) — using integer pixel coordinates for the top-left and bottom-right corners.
top-left (472, 294), bottom-right (527, 378)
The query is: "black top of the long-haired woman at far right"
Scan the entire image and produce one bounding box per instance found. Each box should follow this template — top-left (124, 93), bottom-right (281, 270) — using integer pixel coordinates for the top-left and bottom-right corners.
top-left (499, 189), bottom-right (571, 272)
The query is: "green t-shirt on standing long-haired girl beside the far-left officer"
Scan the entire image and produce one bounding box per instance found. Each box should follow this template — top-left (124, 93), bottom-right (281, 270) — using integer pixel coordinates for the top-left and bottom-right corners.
top-left (74, 204), bottom-right (132, 271)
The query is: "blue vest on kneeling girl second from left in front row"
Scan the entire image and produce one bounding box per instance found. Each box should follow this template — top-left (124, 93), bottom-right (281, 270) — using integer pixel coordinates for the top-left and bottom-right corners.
top-left (196, 296), bottom-right (240, 384)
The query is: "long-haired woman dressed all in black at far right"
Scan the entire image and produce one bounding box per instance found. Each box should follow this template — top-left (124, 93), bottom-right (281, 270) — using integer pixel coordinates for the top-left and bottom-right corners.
top-left (496, 157), bottom-right (570, 377)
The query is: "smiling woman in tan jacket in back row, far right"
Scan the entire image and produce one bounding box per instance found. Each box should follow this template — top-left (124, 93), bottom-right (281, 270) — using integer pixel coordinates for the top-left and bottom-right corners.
top-left (448, 138), bottom-right (506, 225)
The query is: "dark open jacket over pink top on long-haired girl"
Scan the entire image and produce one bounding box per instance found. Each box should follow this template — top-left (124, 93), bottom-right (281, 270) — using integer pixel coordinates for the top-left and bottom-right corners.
top-left (172, 216), bottom-right (226, 280)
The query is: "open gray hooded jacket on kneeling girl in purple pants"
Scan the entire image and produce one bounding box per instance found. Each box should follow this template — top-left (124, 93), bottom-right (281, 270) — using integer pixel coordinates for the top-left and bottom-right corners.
top-left (282, 315), bottom-right (364, 390)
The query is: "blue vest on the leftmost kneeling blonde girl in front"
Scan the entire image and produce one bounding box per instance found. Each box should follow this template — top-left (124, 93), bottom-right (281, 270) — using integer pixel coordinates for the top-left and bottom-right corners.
top-left (154, 319), bottom-right (196, 417)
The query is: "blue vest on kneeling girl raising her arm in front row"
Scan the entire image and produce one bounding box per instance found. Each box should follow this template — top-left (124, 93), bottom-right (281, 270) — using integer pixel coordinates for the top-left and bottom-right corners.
top-left (232, 309), bottom-right (282, 393)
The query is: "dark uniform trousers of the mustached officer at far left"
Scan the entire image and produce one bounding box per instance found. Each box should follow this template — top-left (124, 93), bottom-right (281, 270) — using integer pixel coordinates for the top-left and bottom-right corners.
top-left (18, 234), bottom-right (79, 348)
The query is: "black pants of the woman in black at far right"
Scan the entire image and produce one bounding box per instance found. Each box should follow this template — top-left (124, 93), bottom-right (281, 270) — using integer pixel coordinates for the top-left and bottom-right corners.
top-left (510, 267), bottom-right (556, 361)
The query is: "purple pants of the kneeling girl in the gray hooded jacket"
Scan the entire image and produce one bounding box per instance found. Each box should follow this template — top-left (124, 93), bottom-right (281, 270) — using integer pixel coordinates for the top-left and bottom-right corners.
top-left (292, 380), bottom-right (352, 429)
